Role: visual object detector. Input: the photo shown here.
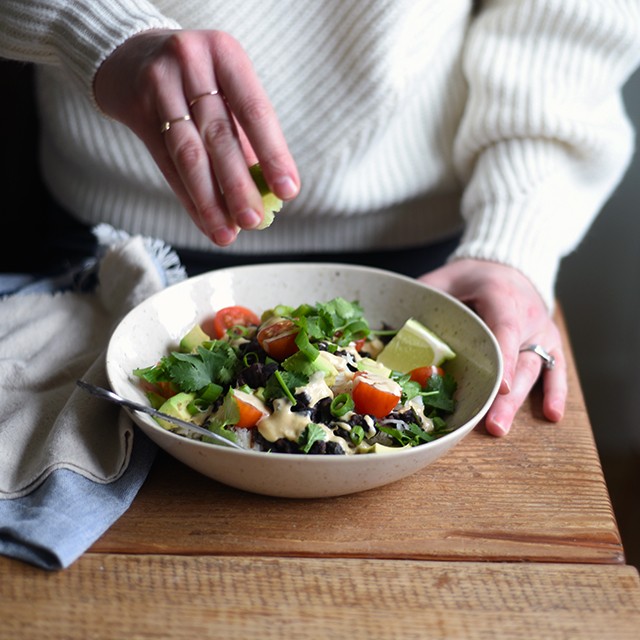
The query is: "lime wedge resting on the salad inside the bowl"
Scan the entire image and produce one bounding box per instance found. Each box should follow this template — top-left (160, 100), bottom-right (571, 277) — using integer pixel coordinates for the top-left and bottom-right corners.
top-left (376, 318), bottom-right (456, 373)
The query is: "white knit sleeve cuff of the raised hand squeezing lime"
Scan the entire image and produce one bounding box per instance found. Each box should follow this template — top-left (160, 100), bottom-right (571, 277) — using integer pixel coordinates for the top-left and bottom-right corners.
top-left (0, 0), bottom-right (180, 101)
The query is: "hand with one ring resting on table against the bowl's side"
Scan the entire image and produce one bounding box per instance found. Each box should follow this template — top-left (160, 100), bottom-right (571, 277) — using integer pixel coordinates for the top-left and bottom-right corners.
top-left (419, 260), bottom-right (567, 436)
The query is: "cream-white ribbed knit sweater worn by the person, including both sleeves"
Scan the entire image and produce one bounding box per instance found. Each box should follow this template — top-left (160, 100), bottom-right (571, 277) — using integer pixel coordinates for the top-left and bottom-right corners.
top-left (0, 0), bottom-right (640, 306)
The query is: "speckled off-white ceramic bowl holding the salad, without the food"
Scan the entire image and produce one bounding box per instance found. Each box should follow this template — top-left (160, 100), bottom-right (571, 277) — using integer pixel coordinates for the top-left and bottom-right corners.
top-left (106, 263), bottom-right (502, 498)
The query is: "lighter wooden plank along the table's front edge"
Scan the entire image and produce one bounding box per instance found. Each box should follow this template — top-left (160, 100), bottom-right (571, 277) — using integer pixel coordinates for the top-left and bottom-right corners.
top-left (0, 554), bottom-right (640, 640)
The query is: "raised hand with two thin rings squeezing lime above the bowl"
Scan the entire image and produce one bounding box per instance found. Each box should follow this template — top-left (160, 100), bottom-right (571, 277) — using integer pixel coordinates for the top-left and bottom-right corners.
top-left (95, 30), bottom-right (300, 246)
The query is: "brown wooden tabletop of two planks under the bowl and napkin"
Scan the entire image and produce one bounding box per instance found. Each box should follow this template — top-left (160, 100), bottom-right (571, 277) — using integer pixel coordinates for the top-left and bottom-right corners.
top-left (0, 308), bottom-right (640, 640)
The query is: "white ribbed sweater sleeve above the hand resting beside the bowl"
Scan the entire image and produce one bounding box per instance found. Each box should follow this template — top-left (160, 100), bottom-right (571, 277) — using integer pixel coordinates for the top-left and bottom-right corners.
top-left (453, 0), bottom-right (640, 308)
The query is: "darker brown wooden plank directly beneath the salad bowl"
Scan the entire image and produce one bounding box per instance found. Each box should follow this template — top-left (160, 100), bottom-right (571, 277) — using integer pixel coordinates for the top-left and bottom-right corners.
top-left (92, 312), bottom-right (624, 563)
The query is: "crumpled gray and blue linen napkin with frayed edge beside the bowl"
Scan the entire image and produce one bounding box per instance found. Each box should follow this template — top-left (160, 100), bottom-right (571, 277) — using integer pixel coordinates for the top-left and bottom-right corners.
top-left (0, 225), bottom-right (186, 568)
